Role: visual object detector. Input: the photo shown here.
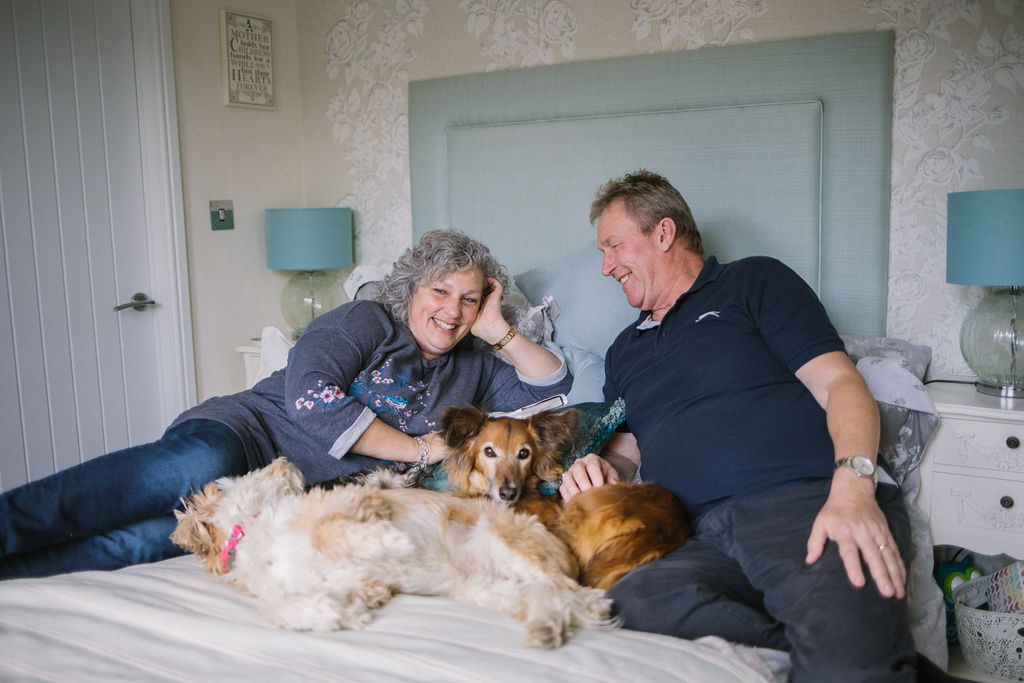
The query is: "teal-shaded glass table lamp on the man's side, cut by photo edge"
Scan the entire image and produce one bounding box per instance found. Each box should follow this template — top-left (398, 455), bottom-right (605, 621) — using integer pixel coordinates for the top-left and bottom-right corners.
top-left (946, 189), bottom-right (1024, 398)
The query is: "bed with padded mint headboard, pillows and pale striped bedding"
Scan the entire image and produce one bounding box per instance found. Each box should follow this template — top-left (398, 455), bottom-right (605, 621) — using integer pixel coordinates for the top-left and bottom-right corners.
top-left (0, 32), bottom-right (946, 681)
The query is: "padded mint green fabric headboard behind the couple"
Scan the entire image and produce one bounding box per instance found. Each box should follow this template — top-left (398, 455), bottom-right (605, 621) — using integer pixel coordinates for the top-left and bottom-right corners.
top-left (409, 32), bottom-right (893, 335)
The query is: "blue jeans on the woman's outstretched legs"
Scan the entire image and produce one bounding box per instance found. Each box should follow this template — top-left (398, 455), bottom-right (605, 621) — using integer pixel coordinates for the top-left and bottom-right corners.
top-left (0, 420), bottom-right (248, 579)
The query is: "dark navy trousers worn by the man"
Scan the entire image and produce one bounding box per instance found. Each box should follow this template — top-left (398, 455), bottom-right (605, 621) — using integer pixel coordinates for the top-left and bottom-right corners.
top-left (609, 480), bottom-right (916, 683)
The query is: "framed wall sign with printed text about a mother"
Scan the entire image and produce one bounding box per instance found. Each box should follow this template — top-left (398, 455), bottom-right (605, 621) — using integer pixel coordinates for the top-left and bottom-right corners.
top-left (220, 9), bottom-right (276, 110)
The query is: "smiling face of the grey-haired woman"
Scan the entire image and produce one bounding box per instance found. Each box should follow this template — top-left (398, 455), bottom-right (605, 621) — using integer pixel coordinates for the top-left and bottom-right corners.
top-left (409, 268), bottom-right (483, 360)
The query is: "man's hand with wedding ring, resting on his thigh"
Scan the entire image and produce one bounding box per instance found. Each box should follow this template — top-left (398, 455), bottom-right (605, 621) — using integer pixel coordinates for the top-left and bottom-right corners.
top-left (807, 478), bottom-right (906, 598)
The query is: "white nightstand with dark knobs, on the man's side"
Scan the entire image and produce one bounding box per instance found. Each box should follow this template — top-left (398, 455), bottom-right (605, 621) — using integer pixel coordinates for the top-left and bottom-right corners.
top-left (918, 382), bottom-right (1024, 558)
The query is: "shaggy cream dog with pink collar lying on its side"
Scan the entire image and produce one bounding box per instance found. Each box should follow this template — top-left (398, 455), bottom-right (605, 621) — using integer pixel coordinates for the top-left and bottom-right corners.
top-left (171, 458), bottom-right (613, 647)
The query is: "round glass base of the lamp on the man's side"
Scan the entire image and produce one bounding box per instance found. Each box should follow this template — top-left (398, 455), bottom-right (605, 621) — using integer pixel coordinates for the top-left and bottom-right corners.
top-left (961, 287), bottom-right (1024, 398)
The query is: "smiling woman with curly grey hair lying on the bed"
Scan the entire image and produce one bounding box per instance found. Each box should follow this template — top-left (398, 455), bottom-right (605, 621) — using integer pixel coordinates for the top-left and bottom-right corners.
top-left (0, 230), bottom-right (572, 579)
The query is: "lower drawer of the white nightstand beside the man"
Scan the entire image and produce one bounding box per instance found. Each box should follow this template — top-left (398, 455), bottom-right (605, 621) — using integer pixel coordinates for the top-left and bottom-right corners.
top-left (930, 472), bottom-right (1024, 556)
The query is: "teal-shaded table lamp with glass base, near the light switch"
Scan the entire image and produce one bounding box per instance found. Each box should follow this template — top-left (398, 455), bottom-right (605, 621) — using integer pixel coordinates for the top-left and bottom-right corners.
top-left (265, 208), bottom-right (352, 339)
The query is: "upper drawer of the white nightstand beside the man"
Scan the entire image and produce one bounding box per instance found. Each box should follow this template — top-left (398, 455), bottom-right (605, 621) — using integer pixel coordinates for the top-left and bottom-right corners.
top-left (932, 417), bottom-right (1024, 475)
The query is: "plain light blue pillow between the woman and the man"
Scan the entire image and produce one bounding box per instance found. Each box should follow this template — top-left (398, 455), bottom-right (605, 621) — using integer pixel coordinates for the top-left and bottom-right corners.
top-left (515, 243), bottom-right (639, 357)
